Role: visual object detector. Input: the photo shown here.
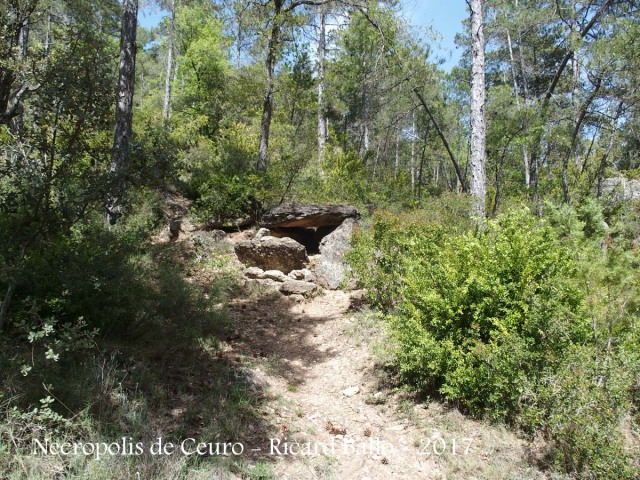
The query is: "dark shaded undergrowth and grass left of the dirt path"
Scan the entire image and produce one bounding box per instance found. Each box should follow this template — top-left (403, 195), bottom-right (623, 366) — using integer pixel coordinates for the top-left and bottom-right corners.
top-left (0, 192), bottom-right (273, 479)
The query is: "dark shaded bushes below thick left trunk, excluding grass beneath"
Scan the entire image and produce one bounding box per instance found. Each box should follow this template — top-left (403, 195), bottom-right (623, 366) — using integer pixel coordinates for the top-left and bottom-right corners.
top-left (0, 191), bottom-right (235, 413)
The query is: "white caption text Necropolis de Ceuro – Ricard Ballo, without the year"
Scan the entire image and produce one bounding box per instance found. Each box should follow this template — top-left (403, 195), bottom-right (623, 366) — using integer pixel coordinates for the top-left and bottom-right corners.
top-left (31, 437), bottom-right (380, 459)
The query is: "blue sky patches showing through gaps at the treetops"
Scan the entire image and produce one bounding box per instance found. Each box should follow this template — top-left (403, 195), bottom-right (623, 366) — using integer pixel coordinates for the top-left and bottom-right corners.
top-left (138, 0), bottom-right (468, 71)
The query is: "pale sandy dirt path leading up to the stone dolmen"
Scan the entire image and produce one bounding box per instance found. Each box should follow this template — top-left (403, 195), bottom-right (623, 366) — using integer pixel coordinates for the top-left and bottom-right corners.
top-left (224, 291), bottom-right (424, 479)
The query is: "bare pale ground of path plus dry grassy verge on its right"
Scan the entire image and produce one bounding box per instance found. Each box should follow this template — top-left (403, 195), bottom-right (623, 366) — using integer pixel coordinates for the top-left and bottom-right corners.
top-left (218, 284), bottom-right (544, 480)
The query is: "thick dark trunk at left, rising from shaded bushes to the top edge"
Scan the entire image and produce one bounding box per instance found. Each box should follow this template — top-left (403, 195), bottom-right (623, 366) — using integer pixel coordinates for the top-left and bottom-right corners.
top-left (106, 0), bottom-right (138, 225)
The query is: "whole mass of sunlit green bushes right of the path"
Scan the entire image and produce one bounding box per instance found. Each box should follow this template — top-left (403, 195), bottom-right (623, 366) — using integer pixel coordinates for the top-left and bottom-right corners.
top-left (351, 205), bottom-right (640, 478)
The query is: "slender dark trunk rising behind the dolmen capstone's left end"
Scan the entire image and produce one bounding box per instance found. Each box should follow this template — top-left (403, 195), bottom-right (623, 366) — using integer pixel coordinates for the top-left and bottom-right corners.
top-left (258, 0), bottom-right (283, 172)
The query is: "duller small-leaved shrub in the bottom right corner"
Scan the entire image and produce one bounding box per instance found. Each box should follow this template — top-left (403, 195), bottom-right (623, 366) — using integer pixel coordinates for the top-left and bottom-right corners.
top-left (539, 345), bottom-right (639, 480)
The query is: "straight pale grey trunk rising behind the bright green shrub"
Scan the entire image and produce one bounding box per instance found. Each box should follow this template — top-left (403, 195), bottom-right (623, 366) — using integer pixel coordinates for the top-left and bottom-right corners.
top-left (469, 0), bottom-right (487, 222)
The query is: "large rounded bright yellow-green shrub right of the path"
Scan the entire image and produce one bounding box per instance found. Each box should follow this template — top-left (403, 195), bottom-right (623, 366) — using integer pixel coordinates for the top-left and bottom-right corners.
top-left (392, 211), bottom-right (589, 420)
